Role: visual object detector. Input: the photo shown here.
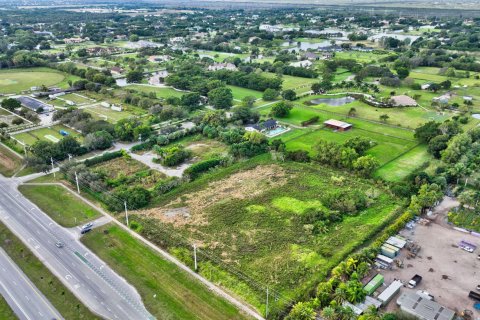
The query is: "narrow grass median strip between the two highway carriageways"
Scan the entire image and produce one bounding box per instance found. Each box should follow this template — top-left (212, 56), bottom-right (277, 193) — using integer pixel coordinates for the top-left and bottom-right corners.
top-left (0, 223), bottom-right (99, 320)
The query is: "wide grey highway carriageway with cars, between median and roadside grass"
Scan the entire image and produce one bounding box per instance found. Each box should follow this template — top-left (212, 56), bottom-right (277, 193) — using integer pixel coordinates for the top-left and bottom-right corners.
top-left (0, 176), bottom-right (154, 320)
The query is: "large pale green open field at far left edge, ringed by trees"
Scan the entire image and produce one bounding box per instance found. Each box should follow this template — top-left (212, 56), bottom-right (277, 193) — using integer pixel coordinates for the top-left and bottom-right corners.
top-left (0, 68), bottom-right (79, 93)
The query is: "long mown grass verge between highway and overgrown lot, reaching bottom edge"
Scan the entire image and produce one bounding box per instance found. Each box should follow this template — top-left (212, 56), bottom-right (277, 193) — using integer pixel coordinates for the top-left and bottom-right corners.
top-left (82, 225), bottom-right (246, 320)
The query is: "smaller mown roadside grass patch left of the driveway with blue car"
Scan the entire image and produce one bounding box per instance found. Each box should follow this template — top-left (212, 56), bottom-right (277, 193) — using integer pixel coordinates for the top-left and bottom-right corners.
top-left (19, 185), bottom-right (100, 227)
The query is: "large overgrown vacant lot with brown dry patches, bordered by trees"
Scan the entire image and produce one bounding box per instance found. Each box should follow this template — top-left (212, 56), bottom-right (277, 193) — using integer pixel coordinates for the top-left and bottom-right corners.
top-left (131, 156), bottom-right (399, 311)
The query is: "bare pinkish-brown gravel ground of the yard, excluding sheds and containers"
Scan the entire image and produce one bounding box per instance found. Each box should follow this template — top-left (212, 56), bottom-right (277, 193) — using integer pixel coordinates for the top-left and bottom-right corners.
top-left (382, 199), bottom-right (480, 318)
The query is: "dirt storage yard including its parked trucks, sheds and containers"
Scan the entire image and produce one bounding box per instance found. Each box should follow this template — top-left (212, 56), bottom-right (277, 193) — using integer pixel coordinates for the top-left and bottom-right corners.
top-left (365, 198), bottom-right (480, 319)
